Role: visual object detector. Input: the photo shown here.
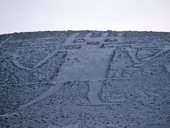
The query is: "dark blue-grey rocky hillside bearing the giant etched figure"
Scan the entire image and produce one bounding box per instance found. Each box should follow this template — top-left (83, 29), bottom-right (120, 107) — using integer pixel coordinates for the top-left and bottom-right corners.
top-left (0, 31), bottom-right (170, 128)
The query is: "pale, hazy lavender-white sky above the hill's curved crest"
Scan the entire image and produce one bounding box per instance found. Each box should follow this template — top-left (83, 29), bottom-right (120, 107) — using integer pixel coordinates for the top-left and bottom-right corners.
top-left (0, 0), bottom-right (170, 34)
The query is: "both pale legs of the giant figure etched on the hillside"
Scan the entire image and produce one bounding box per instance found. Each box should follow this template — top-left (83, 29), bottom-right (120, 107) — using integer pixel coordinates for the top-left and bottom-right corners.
top-left (0, 78), bottom-right (133, 117)
